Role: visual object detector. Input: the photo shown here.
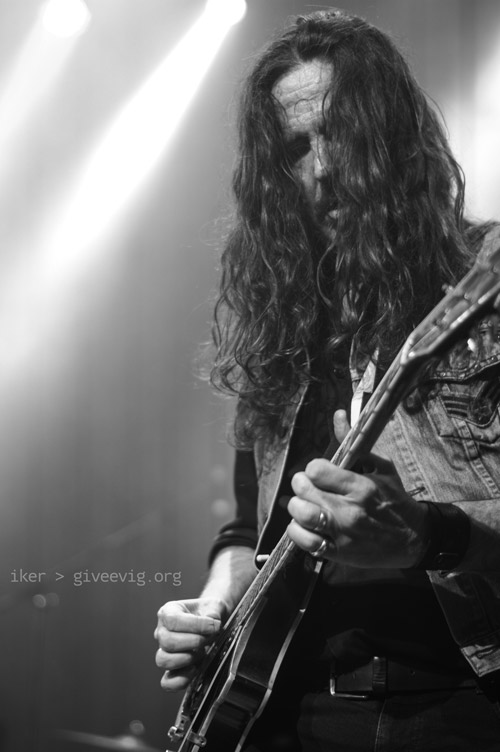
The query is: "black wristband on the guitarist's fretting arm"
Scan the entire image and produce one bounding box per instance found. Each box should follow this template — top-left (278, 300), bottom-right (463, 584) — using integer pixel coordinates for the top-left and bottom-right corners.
top-left (411, 501), bottom-right (470, 571)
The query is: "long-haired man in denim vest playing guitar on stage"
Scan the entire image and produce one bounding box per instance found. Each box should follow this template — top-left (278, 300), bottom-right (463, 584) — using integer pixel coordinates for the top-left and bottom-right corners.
top-left (156, 10), bottom-right (500, 752)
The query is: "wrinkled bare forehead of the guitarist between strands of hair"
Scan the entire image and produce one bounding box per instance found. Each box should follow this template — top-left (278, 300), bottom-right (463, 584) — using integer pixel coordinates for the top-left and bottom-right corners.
top-left (273, 60), bottom-right (332, 131)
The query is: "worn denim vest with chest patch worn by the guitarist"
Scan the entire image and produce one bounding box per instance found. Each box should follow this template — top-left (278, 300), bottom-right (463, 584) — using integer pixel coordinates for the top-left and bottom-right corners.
top-left (254, 227), bottom-right (500, 676)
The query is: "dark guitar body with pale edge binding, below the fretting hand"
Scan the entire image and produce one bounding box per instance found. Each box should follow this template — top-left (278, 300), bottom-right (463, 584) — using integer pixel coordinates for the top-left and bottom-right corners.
top-left (169, 551), bottom-right (321, 752)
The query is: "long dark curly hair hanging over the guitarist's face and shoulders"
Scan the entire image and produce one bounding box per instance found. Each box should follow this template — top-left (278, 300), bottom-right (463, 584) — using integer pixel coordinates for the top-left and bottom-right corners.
top-left (211, 10), bottom-right (488, 446)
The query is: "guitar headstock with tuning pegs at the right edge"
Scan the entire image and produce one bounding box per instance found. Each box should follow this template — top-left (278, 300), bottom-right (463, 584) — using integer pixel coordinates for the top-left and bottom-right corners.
top-left (401, 247), bottom-right (500, 366)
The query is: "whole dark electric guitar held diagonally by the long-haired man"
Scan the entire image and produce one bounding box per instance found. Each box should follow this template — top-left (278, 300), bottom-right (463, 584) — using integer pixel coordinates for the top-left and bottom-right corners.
top-left (167, 239), bottom-right (500, 752)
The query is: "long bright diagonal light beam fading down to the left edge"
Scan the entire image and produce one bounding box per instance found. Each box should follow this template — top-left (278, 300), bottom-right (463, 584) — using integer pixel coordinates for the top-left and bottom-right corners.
top-left (0, 0), bottom-right (248, 376)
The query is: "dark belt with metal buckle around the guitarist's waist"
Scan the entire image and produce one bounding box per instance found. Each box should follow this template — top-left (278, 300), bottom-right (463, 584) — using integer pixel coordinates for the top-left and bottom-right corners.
top-left (330, 656), bottom-right (478, 700)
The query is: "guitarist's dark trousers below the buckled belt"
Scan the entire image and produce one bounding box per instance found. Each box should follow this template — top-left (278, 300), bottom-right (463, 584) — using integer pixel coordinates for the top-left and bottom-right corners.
top-left (245, 689), bottom-right (500, 752)
